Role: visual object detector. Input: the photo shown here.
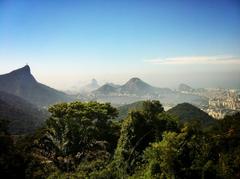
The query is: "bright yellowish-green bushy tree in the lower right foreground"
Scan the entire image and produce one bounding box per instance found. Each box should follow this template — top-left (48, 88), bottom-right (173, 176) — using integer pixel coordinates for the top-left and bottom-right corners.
top-left (144, 121), bottom-right (216, 178)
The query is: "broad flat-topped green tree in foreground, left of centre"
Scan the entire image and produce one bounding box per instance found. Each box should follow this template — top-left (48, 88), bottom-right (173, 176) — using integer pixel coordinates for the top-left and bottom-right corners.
top-left (39, 102), bottom-right (117, 171)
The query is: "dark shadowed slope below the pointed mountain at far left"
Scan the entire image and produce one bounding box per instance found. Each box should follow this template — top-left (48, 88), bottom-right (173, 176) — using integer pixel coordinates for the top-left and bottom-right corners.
top-left (0, 91), bottom-right (47, 134)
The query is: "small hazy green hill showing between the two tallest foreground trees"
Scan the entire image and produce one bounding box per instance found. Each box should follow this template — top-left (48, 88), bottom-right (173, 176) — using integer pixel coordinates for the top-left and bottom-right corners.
top-left (117, 101), bottom-right (143, 120)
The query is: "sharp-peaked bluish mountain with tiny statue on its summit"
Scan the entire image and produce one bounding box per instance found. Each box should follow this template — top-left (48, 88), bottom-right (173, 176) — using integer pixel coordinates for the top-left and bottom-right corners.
top-left (0, 65), bottom-right (71, 106)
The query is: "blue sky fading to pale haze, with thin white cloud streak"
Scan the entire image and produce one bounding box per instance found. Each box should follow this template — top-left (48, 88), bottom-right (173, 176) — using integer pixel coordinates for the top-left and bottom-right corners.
top-left (0, 0), bottom-right (240, 90)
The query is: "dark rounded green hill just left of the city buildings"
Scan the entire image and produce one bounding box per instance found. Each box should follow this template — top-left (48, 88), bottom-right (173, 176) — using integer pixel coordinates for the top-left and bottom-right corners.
top-left (167, 103), bottom-right (214, 124)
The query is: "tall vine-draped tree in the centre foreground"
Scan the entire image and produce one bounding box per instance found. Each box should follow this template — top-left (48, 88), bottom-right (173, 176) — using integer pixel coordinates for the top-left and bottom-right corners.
top-left (113, 101), bottom-right (177, 175)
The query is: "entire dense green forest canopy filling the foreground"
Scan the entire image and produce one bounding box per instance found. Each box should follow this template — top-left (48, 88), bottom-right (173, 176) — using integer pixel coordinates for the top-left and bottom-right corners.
top-left (0, 100), bottom-right (240, 178)
